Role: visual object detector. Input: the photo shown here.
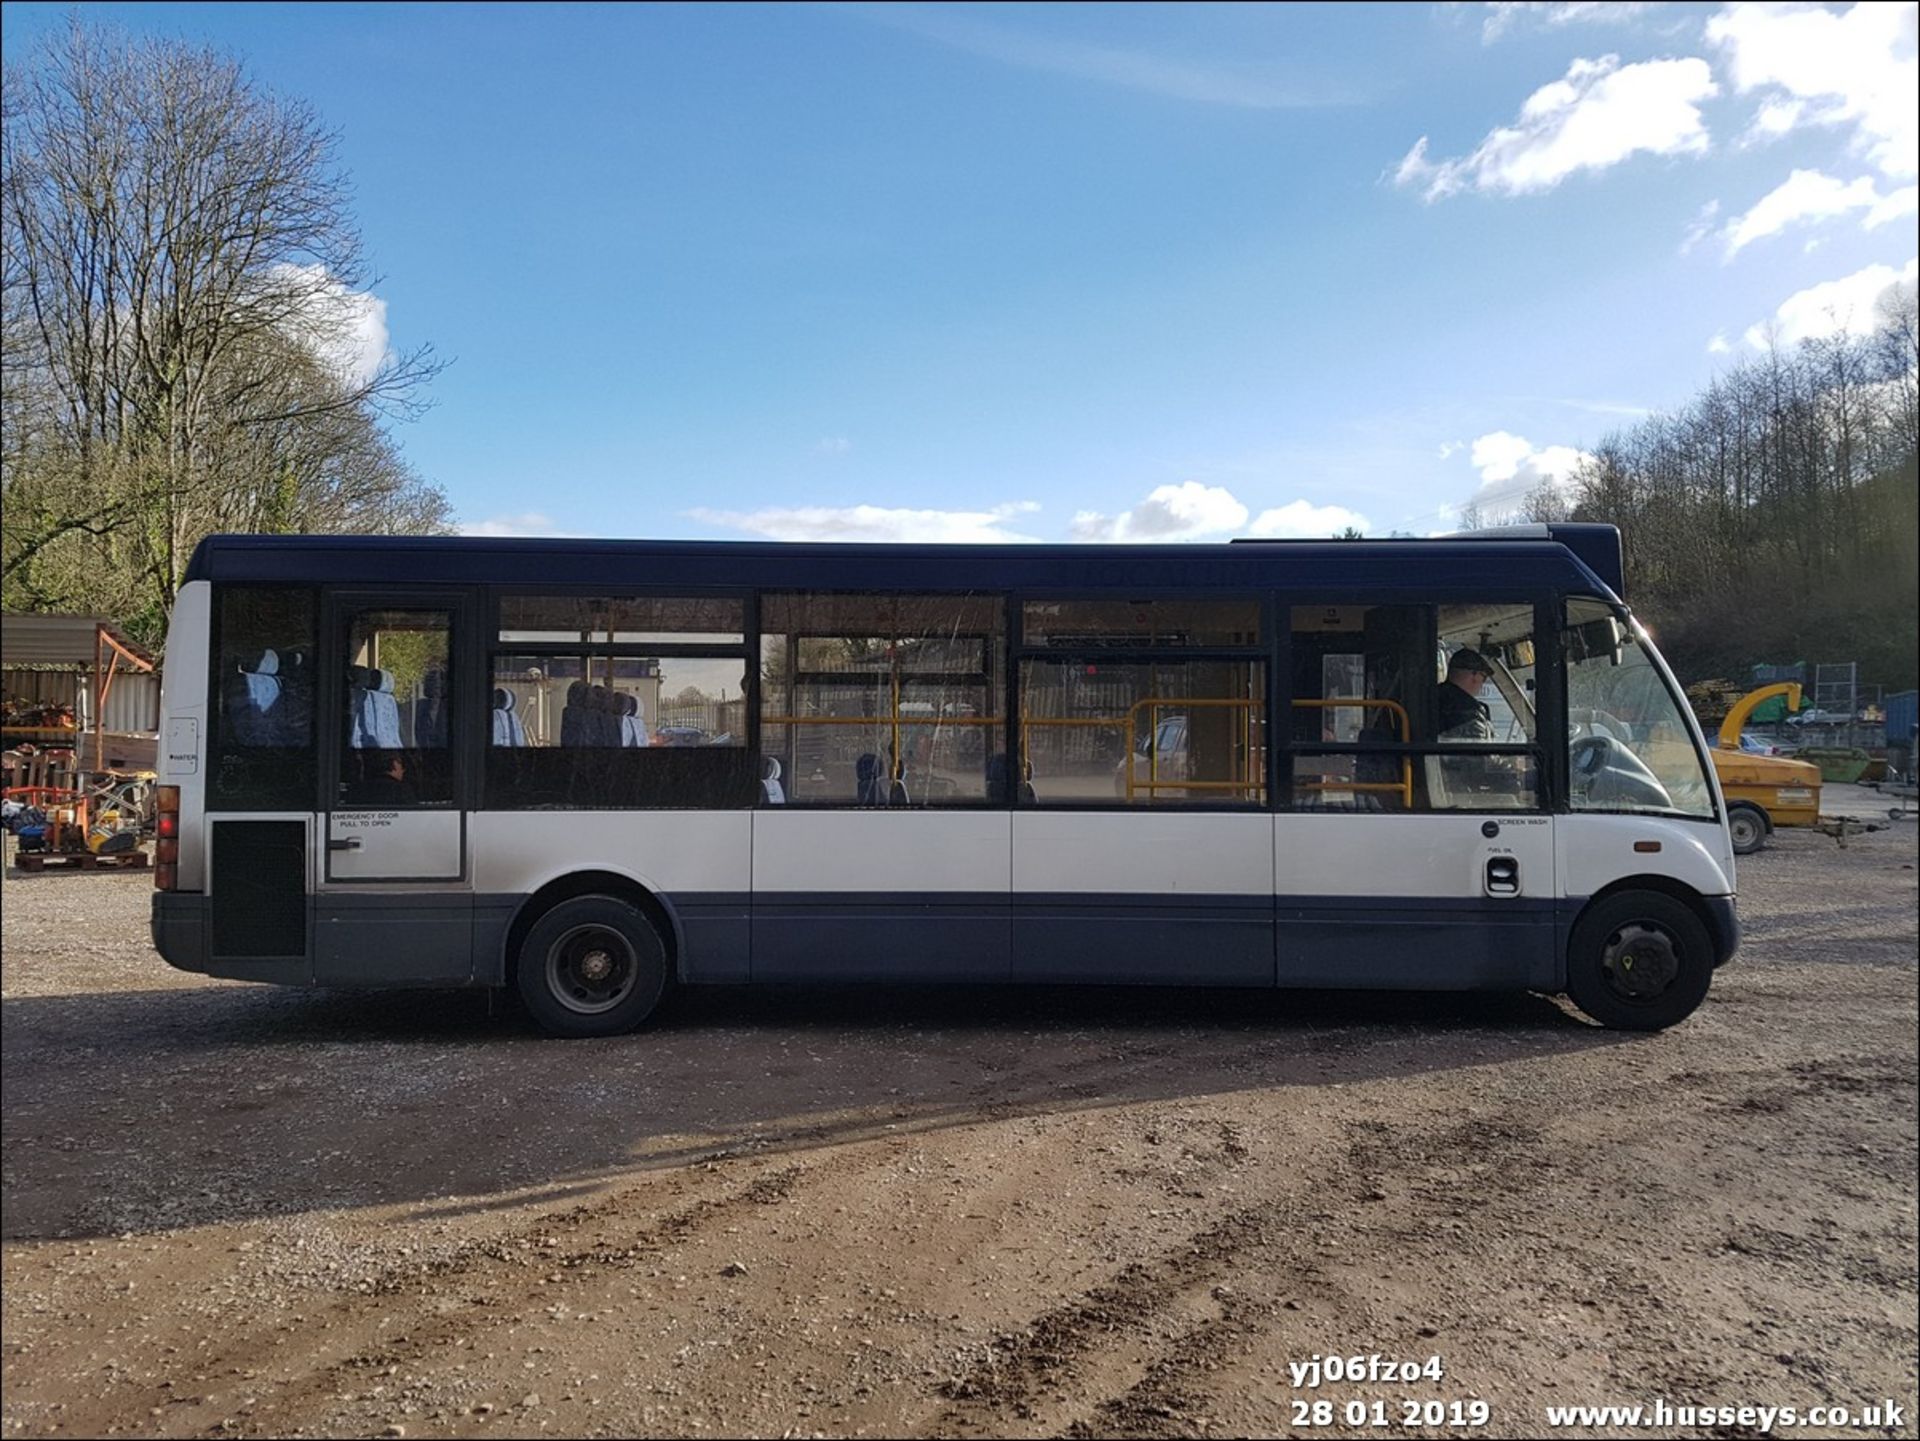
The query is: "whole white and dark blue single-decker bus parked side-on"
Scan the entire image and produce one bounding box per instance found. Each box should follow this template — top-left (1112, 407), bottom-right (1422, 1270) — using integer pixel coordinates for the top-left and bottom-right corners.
top-left (154, 526), bottom-right (1738, 1036)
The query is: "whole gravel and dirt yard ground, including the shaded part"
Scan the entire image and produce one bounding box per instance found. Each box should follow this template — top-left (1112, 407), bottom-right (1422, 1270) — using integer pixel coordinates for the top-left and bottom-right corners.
top-left (0, 821), bottom-right (1920, 1437)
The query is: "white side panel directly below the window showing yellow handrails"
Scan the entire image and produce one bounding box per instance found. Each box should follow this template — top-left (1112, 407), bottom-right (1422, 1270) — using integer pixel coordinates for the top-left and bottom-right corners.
top-left (1014, 812), bottom-right (1273, 896)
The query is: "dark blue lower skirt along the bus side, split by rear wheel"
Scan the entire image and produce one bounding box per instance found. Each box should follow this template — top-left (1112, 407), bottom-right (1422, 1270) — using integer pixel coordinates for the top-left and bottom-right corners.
top-left (154, 892), bottom-right (1574, 990)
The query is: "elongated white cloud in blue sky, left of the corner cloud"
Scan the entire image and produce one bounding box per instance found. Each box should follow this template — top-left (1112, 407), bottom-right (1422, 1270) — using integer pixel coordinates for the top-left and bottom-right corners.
top-left (1394, 56), bottom-right (1718, 200)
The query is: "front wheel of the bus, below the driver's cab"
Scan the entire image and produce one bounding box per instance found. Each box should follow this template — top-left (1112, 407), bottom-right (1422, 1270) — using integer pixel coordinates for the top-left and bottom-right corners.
top-left (1567, 890), bottom-right (1713, 1030)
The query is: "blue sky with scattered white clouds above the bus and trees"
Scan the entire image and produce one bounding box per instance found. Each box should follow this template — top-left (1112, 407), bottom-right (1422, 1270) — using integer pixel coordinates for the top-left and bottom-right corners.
top-left (4, 4), bottom-right (1920, 539)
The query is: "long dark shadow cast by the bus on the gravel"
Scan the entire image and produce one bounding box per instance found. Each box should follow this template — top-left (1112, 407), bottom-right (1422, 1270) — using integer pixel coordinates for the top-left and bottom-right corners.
top-left (0, 984), bottom-right (1644, 1241)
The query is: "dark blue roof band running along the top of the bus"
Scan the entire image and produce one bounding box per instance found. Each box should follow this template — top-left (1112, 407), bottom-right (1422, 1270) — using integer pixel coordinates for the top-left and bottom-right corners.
top-left (186, 524), bottom-right (1624, 597)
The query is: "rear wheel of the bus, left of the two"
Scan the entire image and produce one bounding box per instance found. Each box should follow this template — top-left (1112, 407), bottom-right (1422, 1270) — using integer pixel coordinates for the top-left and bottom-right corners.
top-left (515, 896), bottom-right (670, 1036)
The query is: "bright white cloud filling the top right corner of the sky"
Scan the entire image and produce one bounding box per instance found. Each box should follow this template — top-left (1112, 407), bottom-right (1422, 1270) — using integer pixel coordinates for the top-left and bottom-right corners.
top-left (1707, 0), bottom-right (1920, 178)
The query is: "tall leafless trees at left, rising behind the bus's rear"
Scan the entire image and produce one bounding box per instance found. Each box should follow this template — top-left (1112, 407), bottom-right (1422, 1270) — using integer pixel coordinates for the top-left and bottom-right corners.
top-left (0, 19), bottom-right (445, 640)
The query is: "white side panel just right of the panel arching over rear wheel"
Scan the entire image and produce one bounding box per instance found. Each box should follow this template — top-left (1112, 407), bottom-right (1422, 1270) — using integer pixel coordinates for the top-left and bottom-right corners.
top-left (756, 810), bottom-right (1014, 896)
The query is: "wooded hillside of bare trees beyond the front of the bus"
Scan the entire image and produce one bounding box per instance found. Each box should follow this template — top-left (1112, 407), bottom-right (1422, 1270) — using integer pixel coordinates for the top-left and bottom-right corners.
top-left (1526, 286), bottom-right (1920, 691)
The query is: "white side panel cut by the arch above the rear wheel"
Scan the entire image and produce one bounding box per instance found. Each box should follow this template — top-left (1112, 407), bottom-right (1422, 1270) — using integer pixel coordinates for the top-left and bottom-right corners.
top-left (467, 810), bottom-right (755, 896)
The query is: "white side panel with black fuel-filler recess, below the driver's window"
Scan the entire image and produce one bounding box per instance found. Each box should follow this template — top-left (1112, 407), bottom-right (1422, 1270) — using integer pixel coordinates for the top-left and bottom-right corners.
top-left (1273, 812), bottom-right (1559, 900)
